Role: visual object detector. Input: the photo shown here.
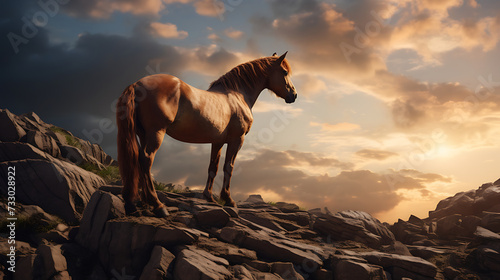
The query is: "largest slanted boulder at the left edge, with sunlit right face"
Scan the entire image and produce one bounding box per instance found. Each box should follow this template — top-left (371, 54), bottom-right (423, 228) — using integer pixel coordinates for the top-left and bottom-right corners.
top-left (0, 143), bottom-right (104, 223)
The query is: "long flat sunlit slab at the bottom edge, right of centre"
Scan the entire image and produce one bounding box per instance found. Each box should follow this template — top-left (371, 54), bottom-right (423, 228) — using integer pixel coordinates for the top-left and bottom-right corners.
top-left (358, 251), bottom-right (437, 278)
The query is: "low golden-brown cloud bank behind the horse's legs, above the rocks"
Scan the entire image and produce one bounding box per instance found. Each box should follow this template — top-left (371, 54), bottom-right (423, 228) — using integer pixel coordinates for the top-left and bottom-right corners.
top-left (156, 148), bottom-right (448, 214)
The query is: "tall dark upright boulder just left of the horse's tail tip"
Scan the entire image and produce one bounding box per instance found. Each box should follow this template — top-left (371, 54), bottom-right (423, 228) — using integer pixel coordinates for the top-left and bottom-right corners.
top-left (76, 190), bottom-right (125, 252)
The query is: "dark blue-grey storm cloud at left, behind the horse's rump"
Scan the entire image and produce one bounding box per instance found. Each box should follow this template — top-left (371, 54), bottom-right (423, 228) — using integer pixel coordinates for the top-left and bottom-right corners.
top-left (0, 1), bottom-right (237, 154)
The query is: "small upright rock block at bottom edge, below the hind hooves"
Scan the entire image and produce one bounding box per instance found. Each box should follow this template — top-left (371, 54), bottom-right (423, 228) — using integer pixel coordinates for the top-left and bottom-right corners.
top-left (139, 246), bottom-right (175, 280)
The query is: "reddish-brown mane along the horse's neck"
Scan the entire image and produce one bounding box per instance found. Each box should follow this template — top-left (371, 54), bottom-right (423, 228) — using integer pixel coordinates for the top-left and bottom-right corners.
top-left (208, 56), bottom-right (292, 91)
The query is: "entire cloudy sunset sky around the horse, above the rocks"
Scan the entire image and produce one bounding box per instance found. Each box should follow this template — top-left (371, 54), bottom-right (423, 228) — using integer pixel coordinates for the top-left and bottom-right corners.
top-left (0, 0), bottom-right (500, 223)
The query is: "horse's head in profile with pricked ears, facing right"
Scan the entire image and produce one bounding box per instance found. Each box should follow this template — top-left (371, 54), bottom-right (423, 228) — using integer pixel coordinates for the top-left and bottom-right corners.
top-left (267, 52), bottom-right (297, 103)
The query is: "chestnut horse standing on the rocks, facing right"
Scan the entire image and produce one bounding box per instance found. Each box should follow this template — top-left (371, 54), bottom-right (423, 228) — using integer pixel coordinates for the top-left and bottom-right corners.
top-left (116, 52), bottom-right (297, 217)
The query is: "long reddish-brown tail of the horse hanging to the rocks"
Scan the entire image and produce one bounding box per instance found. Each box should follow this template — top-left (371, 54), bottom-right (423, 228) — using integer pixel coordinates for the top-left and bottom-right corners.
top-left (116, 84), bottom-right (139, 203)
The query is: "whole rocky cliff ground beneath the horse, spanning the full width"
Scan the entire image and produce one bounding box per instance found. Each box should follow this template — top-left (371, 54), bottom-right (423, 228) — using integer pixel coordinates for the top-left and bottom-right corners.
top-left (0, 110), bottom-right (500, 280)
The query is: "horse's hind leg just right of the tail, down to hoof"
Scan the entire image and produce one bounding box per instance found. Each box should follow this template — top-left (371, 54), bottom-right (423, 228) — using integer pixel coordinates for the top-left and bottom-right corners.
top-left (139, 131), bottom-right (168, 217)
